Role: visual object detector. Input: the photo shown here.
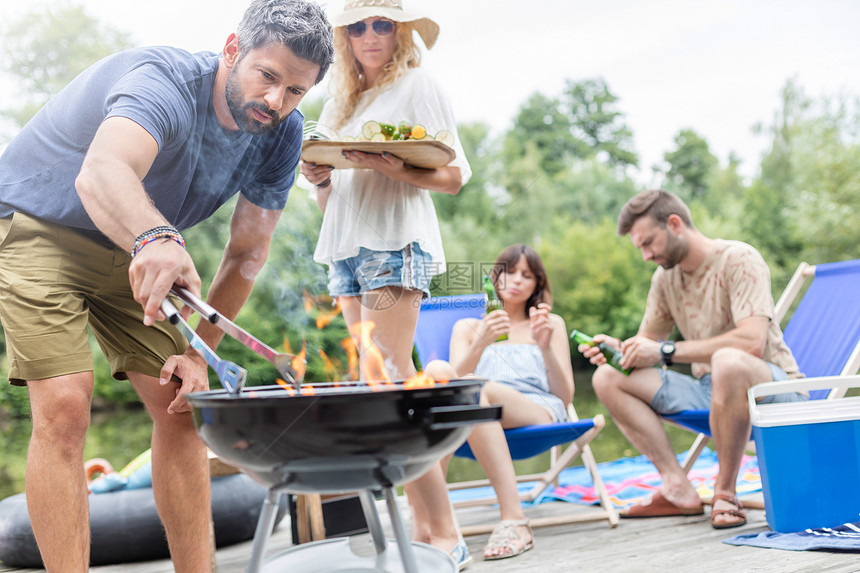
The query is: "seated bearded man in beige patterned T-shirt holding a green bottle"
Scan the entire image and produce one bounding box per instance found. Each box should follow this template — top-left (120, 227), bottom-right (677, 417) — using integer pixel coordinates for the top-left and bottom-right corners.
top-left (579, 190), bottom-right (807, 529)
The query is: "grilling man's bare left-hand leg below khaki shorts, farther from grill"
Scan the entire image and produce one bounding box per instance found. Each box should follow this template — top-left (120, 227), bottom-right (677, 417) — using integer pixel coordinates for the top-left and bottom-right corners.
top-left (26, 372), bottom-right (93, 573)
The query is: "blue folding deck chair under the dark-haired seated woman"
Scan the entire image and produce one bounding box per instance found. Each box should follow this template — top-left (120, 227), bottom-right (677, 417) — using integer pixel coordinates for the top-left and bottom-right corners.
top-left (414, 294), bottom-right (618, 535)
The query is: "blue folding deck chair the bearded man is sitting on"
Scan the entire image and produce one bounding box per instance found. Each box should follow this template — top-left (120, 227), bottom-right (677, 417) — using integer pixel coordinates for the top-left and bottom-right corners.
top-left (663, 259), bottom-right (860, 508)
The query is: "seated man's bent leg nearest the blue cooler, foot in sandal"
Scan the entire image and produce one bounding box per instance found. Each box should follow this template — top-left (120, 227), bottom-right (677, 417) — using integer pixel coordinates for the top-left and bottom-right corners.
top-left (709, 348), bottom-right (772, 523)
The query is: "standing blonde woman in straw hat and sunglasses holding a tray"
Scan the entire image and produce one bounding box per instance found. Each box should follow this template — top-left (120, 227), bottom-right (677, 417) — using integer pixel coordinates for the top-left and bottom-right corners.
top-left (301, 0), bottom-right (471, 565)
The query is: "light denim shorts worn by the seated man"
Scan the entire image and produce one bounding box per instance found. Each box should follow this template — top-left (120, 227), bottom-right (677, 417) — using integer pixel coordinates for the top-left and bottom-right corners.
top-left (651, 362), bottom-right (809, 414)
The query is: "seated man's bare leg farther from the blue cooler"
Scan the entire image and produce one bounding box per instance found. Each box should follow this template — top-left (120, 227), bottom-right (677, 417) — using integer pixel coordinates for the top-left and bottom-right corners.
top-left (592, 365), bottom-right (701, 507)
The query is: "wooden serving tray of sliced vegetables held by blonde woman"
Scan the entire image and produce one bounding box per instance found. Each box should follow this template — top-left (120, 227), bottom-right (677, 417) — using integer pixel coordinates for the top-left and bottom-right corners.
top-left (302, 140), bottom-right (456, 169)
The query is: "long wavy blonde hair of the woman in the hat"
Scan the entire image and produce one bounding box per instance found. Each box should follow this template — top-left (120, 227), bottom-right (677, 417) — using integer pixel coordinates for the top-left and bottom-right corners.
top-left (330, 22), bottom-right (421, 130)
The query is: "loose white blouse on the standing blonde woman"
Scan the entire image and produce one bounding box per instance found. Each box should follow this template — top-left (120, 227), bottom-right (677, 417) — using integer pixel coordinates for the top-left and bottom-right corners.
top-left (314, 68), bottom-right (472, 275)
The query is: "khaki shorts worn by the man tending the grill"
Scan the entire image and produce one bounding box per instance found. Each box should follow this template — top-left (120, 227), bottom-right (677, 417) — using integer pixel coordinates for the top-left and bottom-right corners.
top-left (0, 213), bottom-right (187, 386)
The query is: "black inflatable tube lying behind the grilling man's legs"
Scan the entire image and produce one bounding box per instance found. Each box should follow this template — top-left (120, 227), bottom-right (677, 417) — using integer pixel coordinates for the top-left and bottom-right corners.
top-left (0, 474), bottom-right (287, 568)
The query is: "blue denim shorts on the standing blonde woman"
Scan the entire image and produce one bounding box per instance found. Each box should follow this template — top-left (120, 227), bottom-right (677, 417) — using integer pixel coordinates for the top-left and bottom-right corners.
top-left (328, 243), bottom-right (434, 297)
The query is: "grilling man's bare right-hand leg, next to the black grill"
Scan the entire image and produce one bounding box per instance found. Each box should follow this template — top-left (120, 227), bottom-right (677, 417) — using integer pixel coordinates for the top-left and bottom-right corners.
top-left (129, 373), bottom-right (212, 573)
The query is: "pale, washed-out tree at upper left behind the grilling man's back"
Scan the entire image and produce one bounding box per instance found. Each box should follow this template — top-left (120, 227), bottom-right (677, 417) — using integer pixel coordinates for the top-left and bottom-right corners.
top-left (0, 3), bottom-right (132, 131)
